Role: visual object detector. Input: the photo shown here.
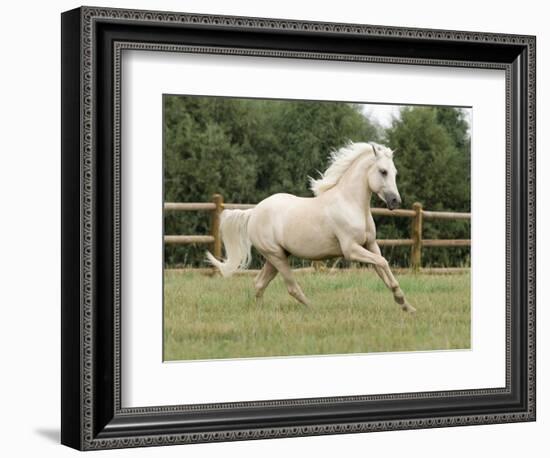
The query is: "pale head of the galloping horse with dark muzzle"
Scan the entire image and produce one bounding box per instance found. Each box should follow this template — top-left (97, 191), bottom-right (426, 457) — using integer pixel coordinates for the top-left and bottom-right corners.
top-left (367, 143), bottom-right (401, 210)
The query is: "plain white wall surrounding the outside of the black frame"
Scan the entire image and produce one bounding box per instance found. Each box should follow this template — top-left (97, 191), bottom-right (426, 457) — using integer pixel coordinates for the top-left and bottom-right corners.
top-left (0, 0), bottom-right (550, 458)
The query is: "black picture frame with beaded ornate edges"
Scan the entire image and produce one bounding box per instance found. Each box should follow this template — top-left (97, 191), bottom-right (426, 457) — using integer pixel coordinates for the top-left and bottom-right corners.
top-left (61, 7), bottom-right (536, 450)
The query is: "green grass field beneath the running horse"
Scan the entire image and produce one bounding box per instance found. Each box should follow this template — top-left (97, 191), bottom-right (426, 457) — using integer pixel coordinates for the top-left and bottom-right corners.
top-left (164, 270), bottom-right (470, 361)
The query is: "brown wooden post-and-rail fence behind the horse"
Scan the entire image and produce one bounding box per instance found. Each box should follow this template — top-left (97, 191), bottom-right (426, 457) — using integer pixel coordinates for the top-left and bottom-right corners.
top-left (164, 194), bottom-right (471, 271)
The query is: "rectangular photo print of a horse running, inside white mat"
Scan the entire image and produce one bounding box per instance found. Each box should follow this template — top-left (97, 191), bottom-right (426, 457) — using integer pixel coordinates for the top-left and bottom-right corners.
top-left (163, 94), bottom-right (472, 361)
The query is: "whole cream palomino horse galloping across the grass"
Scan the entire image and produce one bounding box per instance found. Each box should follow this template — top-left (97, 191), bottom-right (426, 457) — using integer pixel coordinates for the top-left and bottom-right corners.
top-left (207, 143), bottom-right (415, 312)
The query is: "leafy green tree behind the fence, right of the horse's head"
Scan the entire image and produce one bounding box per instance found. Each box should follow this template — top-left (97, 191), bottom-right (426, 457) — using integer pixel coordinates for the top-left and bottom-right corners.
top-left (385, 107), bottom-right (470, 266)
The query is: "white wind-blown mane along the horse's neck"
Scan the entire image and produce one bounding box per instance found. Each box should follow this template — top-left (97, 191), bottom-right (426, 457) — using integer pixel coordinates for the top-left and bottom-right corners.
top-left (309, 142), bottom-right (392, 196)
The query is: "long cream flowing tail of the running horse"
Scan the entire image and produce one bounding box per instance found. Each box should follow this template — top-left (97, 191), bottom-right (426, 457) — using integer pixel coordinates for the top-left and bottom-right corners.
top-left (206, 209), bottom-right (252, 277)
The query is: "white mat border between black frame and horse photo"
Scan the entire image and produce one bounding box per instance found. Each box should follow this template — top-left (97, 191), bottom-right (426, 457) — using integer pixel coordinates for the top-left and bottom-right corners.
top-left (121, 51), bottom-right (506, 407)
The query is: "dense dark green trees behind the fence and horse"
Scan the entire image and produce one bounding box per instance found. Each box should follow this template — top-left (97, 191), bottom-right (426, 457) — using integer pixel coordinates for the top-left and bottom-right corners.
top-left (164, 96), bottom-right (470, 266)
